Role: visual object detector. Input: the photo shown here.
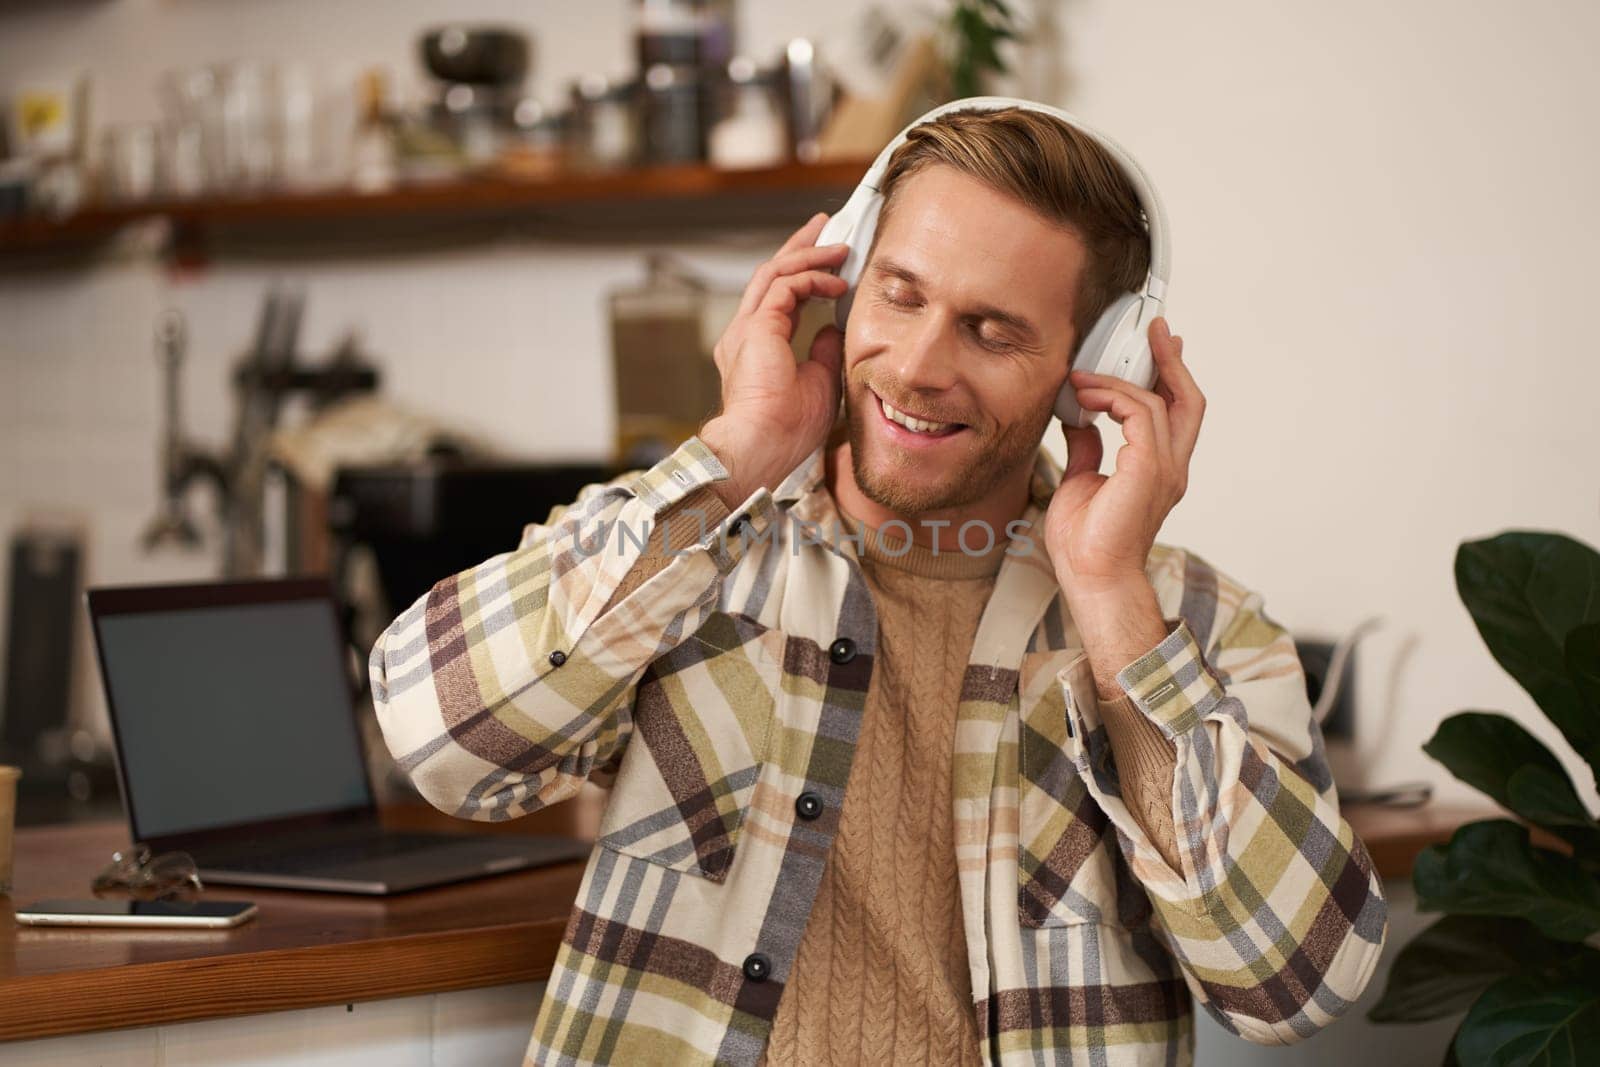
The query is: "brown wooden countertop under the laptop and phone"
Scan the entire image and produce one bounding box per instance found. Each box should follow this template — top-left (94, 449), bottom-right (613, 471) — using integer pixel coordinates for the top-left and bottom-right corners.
top-left (0, 805), bottom-right (1493, 1040)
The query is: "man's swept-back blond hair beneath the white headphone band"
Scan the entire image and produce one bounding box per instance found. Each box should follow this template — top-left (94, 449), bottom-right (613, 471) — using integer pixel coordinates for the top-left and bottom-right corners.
top-left (878, 107), bottom-right (1150, 354)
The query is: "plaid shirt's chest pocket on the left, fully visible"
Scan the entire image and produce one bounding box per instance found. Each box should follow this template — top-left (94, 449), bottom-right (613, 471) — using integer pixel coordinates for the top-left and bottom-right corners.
top-left (598, 613), bottom-right (782, 881)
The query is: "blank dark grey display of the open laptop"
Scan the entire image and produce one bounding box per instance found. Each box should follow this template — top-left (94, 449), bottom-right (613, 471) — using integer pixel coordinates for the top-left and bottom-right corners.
top-left (91, 593), bottom-right (371, 838)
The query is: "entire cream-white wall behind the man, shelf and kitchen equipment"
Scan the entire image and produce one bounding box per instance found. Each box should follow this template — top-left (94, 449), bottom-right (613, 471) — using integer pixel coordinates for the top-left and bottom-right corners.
top-left (0, 0), bottom-right (1600, 809)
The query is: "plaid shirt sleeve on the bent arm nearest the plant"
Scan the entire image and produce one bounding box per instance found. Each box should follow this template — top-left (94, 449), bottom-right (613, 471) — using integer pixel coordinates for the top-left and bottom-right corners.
top-left (1062, 552), bottom-right (1387, 1045)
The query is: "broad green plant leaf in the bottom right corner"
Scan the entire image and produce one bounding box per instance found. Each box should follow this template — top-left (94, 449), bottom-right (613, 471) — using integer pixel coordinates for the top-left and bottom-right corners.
top-left (1454, 949), bottom-right (1600, 1067)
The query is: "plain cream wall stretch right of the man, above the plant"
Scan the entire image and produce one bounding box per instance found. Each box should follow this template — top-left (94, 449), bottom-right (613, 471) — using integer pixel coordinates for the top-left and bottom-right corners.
top-left (1066, 2), bottom-right (1600, 797)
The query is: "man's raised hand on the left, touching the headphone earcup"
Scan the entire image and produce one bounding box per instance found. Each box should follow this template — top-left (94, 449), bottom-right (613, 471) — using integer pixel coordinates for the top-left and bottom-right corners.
top-left (699, 214), bottom-right (848, 509)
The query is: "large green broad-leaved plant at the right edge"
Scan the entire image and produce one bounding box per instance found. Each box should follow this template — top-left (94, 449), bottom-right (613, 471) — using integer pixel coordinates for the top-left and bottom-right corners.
top-left (1368, 531), bottom-right (1600, 1067)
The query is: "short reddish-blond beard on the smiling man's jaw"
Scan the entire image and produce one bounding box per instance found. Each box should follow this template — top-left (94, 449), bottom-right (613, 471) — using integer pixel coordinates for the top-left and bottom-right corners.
top-left (845, 382), bottom-right (1054, 517)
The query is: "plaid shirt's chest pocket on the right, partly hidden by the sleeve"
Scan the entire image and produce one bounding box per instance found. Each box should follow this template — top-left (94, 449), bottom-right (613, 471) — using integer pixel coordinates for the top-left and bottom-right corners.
top-left (1018, 649), bottom-right (1150, 928)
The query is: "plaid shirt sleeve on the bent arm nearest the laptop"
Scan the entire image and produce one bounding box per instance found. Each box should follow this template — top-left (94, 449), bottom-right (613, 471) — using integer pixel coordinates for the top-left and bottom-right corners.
top-left (370, 438), bottom-right (776, 821)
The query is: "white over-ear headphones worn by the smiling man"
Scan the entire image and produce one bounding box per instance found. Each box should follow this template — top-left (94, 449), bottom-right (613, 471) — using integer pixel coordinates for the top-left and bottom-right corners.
top-left (816, 96), bottom-right (1171, 427)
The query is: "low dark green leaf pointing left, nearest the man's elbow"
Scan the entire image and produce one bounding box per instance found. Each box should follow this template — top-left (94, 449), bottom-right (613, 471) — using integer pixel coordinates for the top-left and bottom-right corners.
top-left (1366, 915), bottom-right (1579, 1022)
